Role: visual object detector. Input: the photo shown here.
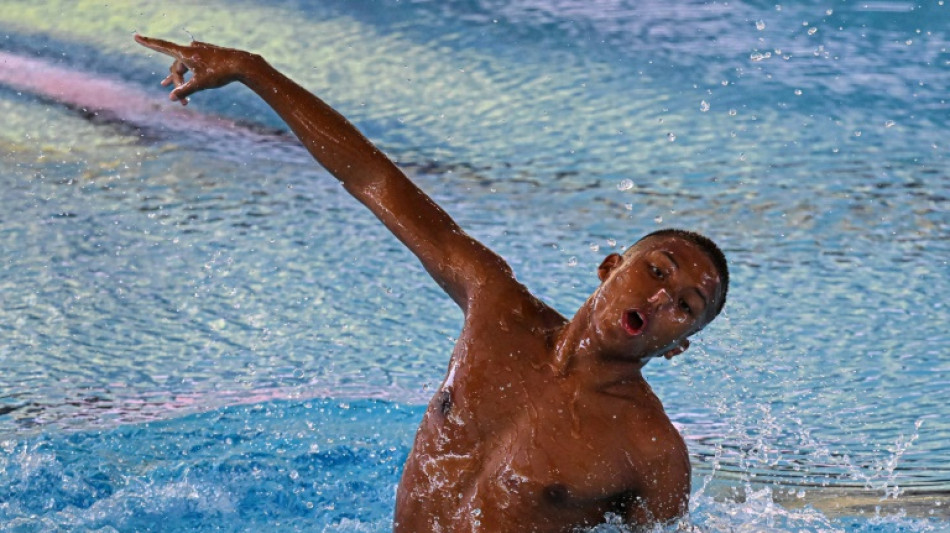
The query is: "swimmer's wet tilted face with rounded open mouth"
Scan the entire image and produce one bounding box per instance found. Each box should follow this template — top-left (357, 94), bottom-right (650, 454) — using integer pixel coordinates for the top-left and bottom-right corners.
top-left (591, 236), bottom-right (722, 360)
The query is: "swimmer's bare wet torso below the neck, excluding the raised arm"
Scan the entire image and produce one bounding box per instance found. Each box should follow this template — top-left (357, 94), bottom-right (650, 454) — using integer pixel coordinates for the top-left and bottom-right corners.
top-left (394, 280), bottom-right (688, 533)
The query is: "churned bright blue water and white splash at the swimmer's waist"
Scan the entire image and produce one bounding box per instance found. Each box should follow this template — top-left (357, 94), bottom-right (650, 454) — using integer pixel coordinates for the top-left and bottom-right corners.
top-left (0, 399), bottom-right (939, 532)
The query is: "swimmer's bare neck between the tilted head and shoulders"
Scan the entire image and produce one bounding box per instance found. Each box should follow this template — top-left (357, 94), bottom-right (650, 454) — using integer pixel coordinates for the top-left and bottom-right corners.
top-left (553, 301), bottom-right (646, 382)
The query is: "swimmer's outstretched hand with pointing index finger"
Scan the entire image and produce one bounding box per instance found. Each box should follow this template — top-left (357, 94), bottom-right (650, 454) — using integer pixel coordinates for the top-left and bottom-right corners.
top-left (135, 35), bottom-right (251, 105)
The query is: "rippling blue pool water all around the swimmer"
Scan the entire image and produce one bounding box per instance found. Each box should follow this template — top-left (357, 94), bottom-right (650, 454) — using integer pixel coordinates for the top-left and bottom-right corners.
top-left (0, 0), bottom-right (950, 531)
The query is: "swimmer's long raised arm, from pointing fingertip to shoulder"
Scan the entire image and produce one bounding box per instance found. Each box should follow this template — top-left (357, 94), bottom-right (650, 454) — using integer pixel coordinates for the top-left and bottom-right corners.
top-left (135, 35), bottom-right (514, 311)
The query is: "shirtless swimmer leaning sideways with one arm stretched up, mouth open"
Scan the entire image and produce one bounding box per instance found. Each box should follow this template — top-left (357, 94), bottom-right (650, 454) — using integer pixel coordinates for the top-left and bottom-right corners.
top-left (135, 36), bottom-right (728, 533)
